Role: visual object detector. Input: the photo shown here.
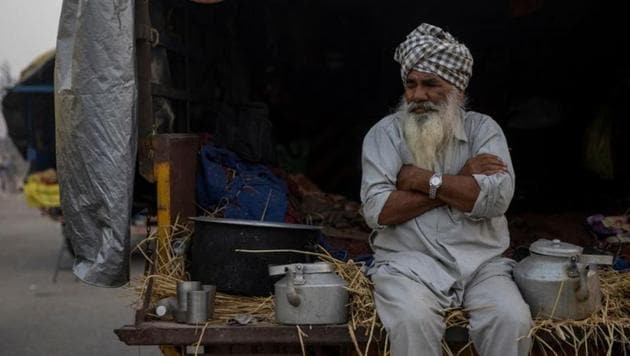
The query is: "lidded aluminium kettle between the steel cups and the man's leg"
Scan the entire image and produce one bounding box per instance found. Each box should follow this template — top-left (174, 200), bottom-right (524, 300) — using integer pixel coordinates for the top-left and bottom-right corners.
top-left (269, 262), bottom-right (348, 324)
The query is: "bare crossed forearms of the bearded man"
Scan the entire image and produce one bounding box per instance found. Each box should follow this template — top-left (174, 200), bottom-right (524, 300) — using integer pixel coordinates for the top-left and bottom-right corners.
top-left (378, 154), bottom-right (508, 225)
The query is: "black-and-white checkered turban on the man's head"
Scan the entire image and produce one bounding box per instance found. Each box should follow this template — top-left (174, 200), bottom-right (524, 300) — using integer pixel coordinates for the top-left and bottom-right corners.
top-left (394, 23), bottom-right (473, 91)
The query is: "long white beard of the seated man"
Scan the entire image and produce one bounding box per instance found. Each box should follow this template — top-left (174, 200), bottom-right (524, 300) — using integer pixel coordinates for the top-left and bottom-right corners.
top-left (398, 95), bottom-right (462, 171)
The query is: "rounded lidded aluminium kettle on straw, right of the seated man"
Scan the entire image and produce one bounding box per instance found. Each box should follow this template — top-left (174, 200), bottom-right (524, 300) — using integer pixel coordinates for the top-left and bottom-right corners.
top-left (514, 239), bottom-right (612, 320)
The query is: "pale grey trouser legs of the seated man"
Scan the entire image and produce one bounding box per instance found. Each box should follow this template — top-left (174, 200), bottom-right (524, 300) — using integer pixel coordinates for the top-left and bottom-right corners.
top-left (372, 259), bottom-right (532, 356)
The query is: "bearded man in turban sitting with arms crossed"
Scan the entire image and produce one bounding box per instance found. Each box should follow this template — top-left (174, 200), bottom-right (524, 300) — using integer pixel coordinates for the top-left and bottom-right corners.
top-left (361, 24), bottom-right (532, 356)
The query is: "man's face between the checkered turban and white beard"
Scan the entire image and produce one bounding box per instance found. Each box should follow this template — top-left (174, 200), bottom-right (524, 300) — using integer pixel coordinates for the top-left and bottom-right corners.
top-left (404, 70), bottom-right (455, 114)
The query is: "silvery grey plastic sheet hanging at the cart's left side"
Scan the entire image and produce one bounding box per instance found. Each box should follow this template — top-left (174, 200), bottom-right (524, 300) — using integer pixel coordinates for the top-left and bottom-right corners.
top-left (55, 0), bottom-right (137, 287)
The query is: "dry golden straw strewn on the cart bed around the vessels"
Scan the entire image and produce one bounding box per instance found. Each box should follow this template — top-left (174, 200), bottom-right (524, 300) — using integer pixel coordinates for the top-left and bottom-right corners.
top-left (134, 224), bottom-right (630, 355)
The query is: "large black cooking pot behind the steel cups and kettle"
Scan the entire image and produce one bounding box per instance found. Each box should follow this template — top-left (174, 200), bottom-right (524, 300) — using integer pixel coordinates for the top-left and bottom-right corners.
top-left (189, 217), bottom-right (321, 296)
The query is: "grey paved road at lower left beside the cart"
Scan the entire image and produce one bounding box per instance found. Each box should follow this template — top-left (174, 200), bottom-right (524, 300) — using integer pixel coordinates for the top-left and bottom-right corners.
top-left (0, 192), bottom-right (160, 356)
